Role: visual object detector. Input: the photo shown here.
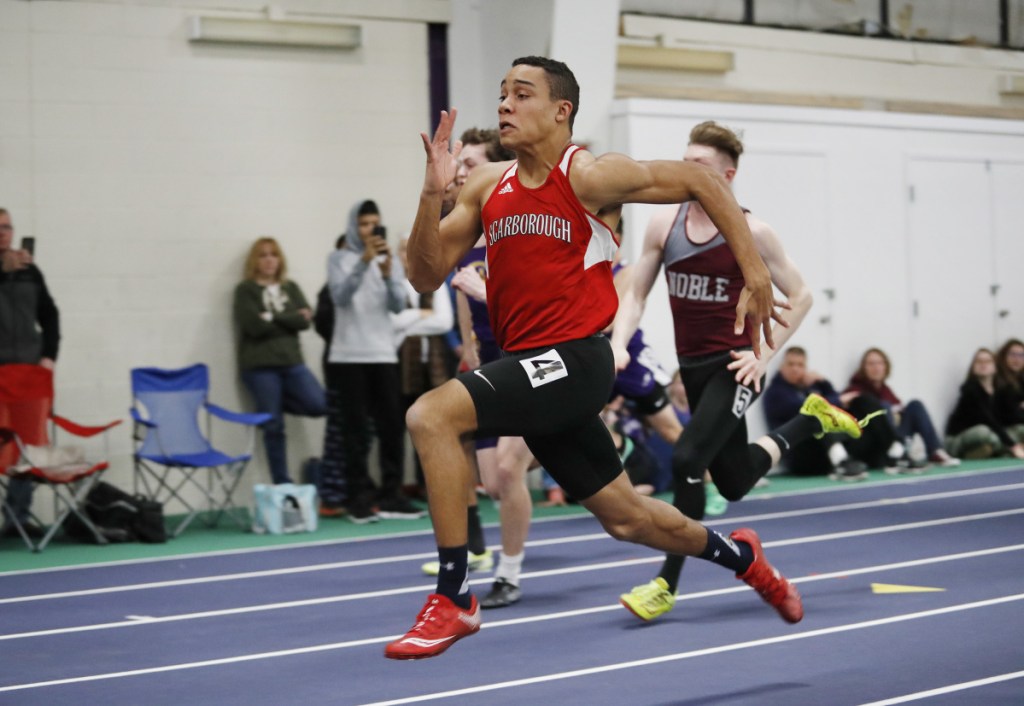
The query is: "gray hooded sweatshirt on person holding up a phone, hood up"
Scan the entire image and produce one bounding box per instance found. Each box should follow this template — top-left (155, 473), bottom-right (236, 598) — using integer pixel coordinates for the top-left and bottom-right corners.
top-left (327, 201), bottom-right (409, 363)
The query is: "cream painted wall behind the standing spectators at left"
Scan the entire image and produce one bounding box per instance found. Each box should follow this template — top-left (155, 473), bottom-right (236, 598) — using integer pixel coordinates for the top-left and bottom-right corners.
top-left (0, 0), bottom-right (446, 511)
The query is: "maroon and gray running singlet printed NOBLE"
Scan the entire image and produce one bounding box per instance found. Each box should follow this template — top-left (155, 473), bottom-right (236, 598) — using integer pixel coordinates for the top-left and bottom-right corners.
top-left (664, 203), bottom-right (751, 356)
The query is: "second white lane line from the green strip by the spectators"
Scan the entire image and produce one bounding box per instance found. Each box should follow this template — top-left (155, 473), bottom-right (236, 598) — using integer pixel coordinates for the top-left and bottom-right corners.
top-left (0, 483), bottom-right (1024, 606)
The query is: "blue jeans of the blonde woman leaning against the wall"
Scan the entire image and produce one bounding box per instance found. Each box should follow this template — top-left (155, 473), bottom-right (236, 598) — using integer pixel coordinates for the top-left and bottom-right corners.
top-left (242, 365), bottom-right (327, 483)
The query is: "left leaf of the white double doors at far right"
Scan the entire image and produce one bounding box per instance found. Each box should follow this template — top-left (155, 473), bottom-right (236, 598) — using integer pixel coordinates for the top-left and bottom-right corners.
top-left (909, 159), bottom-right (994, 422)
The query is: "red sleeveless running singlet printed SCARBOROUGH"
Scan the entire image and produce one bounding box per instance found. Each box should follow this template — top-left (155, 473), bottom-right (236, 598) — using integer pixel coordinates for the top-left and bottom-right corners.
top-left (481, 144), bottom-right (618, 350)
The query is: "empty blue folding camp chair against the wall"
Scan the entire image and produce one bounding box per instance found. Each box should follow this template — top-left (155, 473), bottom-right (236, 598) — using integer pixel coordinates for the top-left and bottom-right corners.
top-left (131, 364), bottom-right (271, 537)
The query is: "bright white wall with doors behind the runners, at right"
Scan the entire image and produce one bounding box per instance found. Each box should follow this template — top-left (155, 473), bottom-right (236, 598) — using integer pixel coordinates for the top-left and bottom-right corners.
top-left (612, 99), bottom-right (1024, 438)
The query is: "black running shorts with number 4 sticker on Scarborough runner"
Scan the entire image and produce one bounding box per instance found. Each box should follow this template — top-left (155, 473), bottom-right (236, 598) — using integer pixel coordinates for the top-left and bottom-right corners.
top-left (457, 336), bottom-right (623, 500)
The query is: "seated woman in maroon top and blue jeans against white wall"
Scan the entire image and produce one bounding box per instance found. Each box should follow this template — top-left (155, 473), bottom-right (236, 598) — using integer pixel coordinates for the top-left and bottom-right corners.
top-left (840, 348), bottom-right (959, 472)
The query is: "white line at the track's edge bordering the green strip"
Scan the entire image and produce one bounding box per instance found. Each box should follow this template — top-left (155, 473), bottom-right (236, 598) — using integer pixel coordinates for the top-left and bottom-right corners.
top-left (0, 465), bottom-right (1024, 579)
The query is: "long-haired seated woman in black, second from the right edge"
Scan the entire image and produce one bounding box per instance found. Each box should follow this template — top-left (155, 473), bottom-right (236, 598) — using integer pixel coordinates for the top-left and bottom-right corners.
top-left (946, 348), bottom-right (1024, 458)
